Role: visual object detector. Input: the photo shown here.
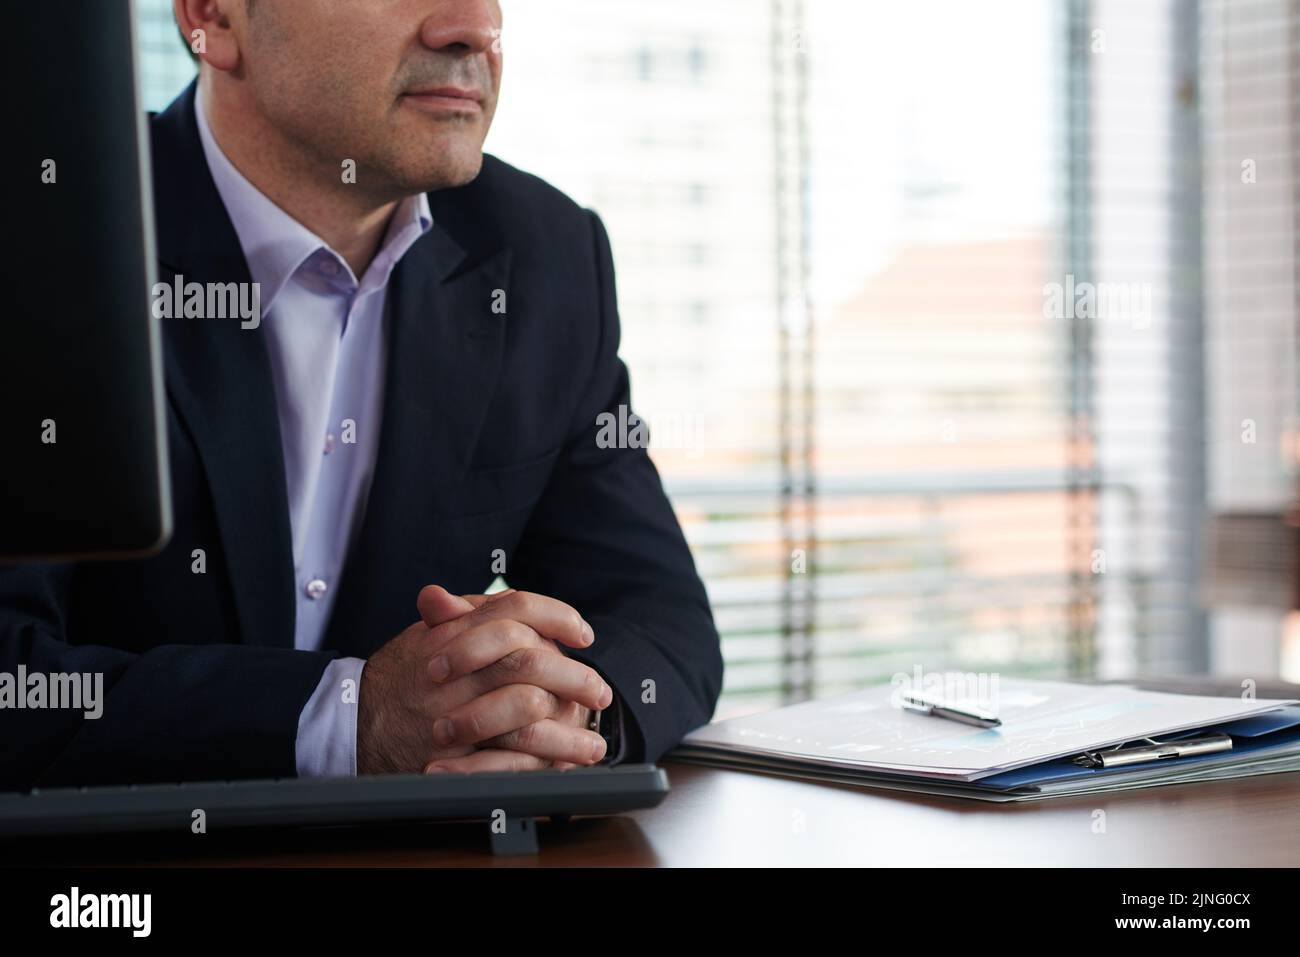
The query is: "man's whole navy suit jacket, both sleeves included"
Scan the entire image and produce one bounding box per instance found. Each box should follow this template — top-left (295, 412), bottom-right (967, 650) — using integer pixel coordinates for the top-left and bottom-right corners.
top-left (0, 86), bottom-right (723, 789)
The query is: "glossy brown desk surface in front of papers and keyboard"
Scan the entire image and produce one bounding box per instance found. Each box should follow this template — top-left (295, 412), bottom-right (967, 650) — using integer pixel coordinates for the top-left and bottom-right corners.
top-left (20, 670), bottom-right (1300, 867)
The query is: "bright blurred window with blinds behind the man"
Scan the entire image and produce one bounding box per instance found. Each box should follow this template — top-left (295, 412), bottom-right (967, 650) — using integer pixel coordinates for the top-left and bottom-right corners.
top-left (140, 0), bottom-right (1300, 716)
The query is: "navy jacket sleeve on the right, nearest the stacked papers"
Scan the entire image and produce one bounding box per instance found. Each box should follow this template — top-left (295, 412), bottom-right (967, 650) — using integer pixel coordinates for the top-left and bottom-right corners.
top-left (508, 212), bottom-right (723, 761)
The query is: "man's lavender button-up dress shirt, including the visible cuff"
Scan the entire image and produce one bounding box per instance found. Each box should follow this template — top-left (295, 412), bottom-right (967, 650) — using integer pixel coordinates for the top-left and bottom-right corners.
top-left (195, 92), bottom-right (433, 776)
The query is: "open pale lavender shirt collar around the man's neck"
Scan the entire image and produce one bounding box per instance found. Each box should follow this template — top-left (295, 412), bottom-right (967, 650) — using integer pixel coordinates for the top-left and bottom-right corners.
top-left (194, 92), bottom-right (433, 316)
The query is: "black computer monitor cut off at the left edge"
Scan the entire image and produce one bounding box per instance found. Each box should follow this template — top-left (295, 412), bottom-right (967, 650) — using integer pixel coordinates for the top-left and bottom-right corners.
top-left (0, 0), bottom-right (170, 560)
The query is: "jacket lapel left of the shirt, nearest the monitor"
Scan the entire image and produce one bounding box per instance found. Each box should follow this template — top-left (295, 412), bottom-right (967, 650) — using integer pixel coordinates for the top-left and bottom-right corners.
top-left (152, 85), bottom-right (294, 648)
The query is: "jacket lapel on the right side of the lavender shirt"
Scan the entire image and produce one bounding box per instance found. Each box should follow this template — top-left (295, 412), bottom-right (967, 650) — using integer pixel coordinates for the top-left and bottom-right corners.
top-left (325, 226), bottom-right (511, 655)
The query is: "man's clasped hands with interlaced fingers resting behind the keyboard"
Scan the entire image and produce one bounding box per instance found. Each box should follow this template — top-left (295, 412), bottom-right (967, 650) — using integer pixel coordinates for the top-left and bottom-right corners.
top-left (356, 585), bottom-right (614, 774)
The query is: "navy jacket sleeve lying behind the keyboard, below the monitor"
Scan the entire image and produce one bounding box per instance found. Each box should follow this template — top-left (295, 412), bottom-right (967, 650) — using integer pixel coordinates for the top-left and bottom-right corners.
top-left (0, 564), bottom-right (332, 791)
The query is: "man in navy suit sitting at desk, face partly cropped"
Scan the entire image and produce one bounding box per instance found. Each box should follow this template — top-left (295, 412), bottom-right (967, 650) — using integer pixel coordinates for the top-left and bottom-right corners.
top-left (0, 0), bottom-right (722, 788)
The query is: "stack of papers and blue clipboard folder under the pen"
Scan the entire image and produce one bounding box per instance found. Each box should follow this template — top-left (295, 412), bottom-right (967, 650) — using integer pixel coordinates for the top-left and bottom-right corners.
top-left (671, 680), bottom-right (1300, 801)
